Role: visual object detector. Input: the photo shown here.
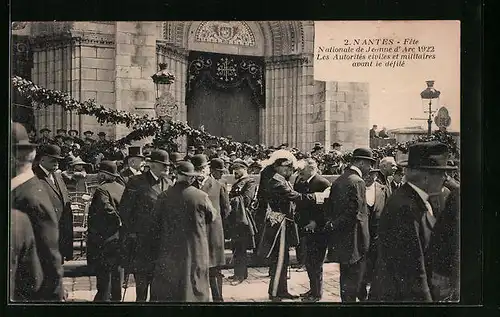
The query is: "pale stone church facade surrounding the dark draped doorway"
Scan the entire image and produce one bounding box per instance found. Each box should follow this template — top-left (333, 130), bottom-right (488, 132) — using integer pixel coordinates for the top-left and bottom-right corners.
top-left (13, 21), bottom-right (369, 150)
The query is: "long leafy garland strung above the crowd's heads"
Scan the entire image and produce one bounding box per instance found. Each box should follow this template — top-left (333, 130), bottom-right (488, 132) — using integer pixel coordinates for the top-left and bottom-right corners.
top-left (12, 76), bottom-right (460, 164)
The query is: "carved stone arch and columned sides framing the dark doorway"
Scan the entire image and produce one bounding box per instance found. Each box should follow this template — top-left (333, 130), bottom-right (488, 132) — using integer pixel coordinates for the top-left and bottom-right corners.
top-left (157, 21), bottom-right (316, 148)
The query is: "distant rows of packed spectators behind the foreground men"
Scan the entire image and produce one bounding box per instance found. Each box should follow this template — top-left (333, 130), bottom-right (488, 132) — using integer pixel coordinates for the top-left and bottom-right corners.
top-left (23, 128), bottom-right (345, 175)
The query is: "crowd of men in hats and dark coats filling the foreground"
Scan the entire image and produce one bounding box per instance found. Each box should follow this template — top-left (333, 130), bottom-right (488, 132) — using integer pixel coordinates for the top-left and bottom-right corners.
top-left (10, 123), bottom-right (460, 302)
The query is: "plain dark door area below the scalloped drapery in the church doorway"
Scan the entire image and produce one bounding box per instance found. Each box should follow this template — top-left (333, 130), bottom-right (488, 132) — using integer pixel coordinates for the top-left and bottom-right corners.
top-left (187, 83), bottom-right (259, 144)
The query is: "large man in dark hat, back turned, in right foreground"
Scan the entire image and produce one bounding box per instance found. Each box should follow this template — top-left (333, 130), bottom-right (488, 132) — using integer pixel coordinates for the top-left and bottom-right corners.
top-left (370, 141), bottom-right (453, 302)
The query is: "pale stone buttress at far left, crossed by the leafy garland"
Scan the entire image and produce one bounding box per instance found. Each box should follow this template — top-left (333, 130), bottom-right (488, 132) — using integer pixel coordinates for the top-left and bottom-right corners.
top-left (30, 22), bottom-right (115, 138)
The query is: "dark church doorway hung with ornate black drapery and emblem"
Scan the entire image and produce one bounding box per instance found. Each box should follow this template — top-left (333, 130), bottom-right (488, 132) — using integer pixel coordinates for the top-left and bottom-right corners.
top-left (186, 51), bottom-right (265, 144)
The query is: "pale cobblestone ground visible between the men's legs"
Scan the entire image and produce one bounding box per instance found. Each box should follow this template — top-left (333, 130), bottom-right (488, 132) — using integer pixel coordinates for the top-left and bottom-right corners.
top-left (64, 263), bottom-right (340, 302)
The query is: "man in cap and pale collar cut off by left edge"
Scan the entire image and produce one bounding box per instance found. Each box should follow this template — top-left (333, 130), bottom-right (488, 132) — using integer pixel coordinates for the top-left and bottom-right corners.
top-left (10, 122), bottom-right (64, 301)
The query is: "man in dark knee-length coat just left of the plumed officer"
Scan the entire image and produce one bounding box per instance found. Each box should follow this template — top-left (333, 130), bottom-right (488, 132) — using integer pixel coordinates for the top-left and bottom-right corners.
top-left (227, 159), bottom-right (257, 285)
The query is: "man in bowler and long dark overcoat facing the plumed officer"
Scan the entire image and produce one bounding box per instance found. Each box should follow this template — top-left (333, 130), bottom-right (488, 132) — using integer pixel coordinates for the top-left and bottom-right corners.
top-left (326, 148), bottom-right (375, 302)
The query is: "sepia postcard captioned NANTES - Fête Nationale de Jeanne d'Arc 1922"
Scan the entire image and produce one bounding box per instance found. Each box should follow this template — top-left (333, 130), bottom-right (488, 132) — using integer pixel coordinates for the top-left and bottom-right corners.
top-left (9, 20), bottom-right (461, 304)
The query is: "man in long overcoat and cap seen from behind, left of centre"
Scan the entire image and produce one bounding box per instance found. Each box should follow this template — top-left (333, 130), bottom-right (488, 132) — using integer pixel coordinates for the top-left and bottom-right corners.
top-left (151, 162), bottom-right (218, 302)
